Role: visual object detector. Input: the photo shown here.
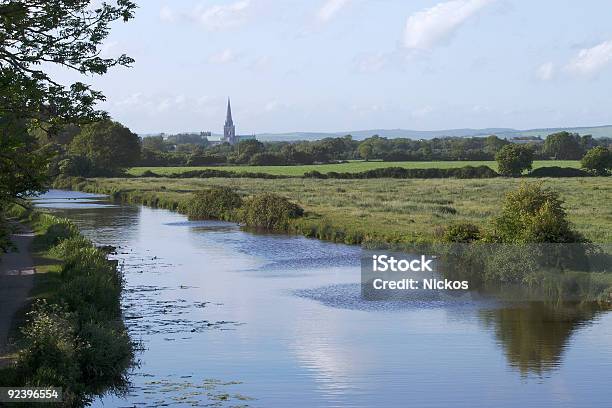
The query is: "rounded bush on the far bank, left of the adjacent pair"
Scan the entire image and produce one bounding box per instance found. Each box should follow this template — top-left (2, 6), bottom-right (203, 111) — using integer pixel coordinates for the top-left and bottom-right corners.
top-left (182, 186), bottom-right (242, 220)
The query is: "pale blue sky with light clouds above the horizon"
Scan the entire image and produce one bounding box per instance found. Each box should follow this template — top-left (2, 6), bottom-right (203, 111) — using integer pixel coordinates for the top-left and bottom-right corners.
top-left (47, 0), bottom-right (612, 134)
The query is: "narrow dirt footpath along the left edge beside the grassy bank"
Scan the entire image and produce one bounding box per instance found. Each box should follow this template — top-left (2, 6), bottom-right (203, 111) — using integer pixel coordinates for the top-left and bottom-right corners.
top-left (0, 226), bottom-right (35, 367)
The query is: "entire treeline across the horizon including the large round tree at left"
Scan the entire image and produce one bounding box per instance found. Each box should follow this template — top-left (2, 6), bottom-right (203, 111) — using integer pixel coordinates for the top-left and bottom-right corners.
top-left (37, 119), bottom-right (612, 178)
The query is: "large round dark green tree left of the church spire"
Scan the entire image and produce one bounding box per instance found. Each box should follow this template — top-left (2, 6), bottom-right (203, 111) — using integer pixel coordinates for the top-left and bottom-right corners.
top-left (70, 120), bottom-right (140, 174)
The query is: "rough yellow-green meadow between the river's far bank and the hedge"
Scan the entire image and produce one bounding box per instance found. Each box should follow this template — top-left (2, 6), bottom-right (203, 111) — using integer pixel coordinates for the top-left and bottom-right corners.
top-left (74, 177), bottom-right (612, 243)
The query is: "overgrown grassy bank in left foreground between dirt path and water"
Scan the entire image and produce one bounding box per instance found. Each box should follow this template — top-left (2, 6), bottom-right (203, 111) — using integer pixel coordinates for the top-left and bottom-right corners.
top-left (0, 210), bottom-right (134, 407)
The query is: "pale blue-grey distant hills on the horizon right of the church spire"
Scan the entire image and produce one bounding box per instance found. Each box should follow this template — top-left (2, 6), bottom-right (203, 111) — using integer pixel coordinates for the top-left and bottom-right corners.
top-left (257, 125), bottom-right (612, 141)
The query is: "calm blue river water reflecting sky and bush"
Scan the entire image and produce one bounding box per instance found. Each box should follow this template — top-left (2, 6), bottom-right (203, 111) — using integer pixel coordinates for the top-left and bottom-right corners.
top-left (37, 190), bottom-right (612, 408)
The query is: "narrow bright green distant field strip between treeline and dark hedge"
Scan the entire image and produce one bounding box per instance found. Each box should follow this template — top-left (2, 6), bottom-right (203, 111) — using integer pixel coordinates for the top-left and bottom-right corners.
top-left (129, 160), bottom-right (580, 176)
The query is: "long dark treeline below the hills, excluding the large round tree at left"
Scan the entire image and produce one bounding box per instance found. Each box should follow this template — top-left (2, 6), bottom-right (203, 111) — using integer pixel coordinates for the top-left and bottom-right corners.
top-left (140, 132), bottom-right (612, 167)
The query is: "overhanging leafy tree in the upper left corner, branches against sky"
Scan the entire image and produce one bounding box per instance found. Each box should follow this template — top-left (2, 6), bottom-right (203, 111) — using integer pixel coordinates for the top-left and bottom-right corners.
top-left (0, 0), bottom-right (136, 201)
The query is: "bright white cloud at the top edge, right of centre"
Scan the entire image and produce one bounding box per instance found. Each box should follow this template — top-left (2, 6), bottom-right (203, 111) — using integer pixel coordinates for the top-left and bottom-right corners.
top-left (404, 0), bottom-right (495, 50)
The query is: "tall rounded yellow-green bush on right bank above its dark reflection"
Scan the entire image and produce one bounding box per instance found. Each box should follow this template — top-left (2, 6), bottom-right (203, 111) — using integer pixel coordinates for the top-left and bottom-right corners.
top-left (493, 183), bottom-right (584, 244)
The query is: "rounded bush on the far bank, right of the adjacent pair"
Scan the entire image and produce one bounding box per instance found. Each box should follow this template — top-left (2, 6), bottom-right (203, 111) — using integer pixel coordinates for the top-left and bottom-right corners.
top-left (240, 193), bottom-right (304, 231)
